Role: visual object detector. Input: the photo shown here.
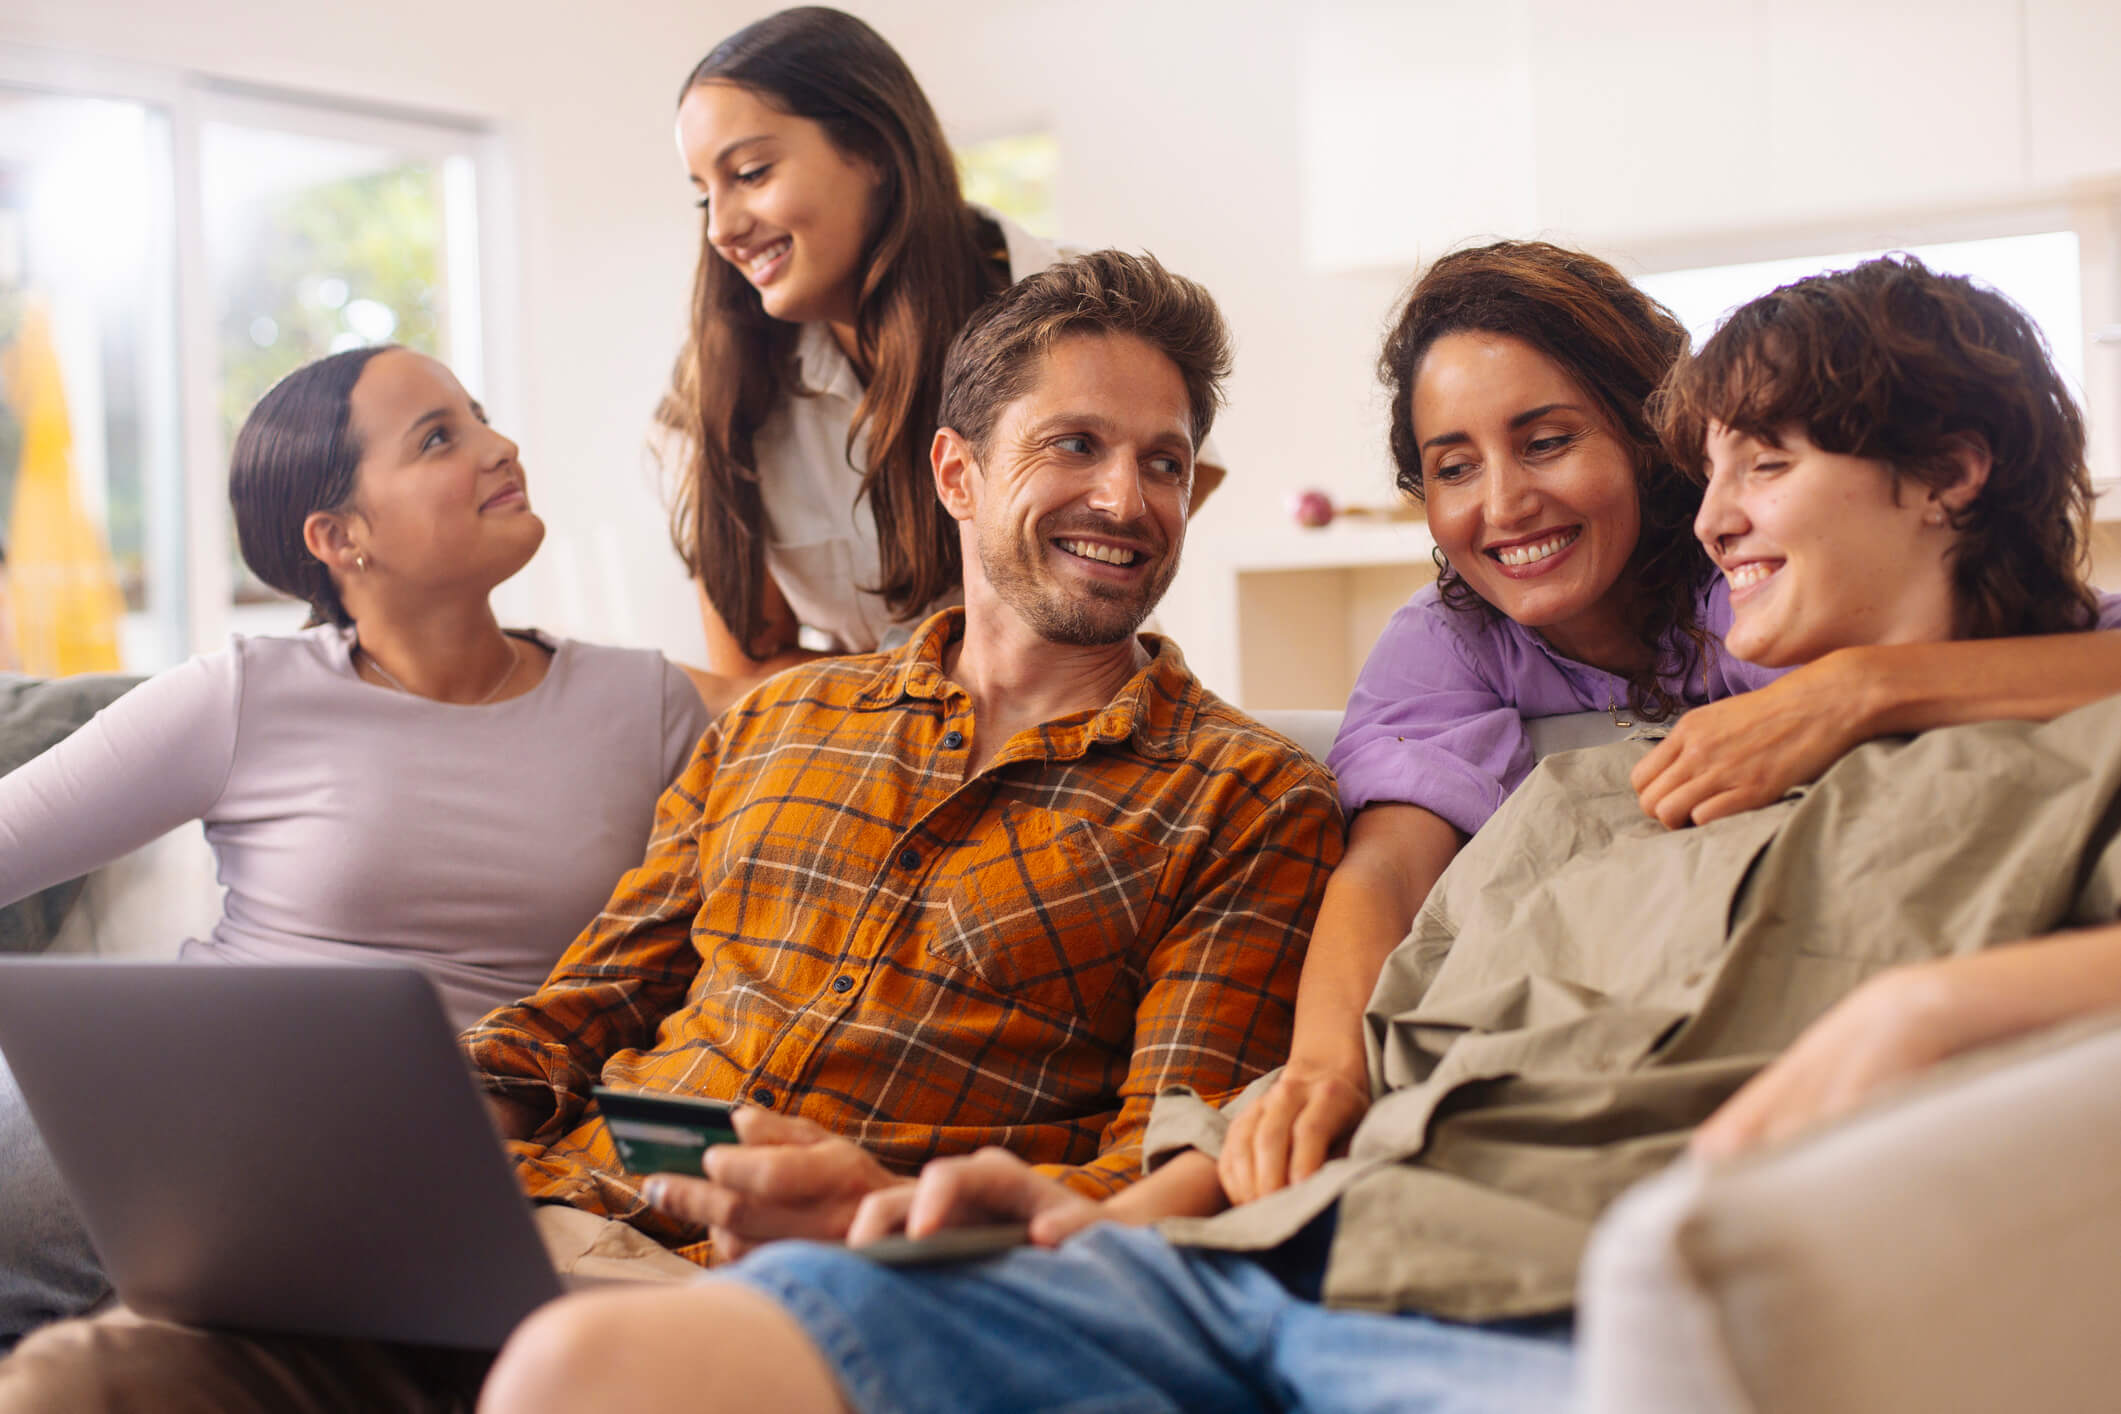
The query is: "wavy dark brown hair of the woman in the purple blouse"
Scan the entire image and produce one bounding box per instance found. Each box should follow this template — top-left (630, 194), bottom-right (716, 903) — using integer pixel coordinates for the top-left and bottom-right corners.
top-left (1377, 240), bottom-right (1710, 721)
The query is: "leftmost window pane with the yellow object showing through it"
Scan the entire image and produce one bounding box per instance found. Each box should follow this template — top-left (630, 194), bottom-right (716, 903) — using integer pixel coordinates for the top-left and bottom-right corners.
top-left (0, 83), bottom-right (185, 674)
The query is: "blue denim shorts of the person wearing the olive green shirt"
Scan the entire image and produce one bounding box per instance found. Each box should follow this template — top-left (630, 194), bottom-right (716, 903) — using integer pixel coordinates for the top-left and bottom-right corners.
top-left (725, 1223), bottom-right (1574, 1414)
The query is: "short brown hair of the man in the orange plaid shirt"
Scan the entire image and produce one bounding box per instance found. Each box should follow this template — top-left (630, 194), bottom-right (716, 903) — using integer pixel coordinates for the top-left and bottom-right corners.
top-left (937, 250), bottom-right (1230, 456)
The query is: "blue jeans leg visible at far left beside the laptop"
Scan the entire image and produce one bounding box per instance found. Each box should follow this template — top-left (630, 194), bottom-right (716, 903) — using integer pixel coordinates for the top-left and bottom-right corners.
top-left (0, 1062), bottom-right (110, 1355)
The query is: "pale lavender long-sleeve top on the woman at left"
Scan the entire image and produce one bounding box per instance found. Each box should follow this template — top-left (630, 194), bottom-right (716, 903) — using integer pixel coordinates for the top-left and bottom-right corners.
top-left (0, 628), bottom-right (708, 1026)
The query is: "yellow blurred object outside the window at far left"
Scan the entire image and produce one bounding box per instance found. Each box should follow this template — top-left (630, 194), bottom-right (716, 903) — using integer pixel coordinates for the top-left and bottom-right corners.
top-left (6, 303), bottom-right (125, 678)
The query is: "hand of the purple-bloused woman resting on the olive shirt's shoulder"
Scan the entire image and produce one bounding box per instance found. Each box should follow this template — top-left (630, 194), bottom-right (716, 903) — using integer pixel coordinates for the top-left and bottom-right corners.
top-left (1629, 655), bottom-right (1871, 829)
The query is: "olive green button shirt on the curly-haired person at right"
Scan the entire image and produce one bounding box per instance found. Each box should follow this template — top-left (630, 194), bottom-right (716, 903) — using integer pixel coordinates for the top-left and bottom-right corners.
top-left (1143, 700), bottom-right (2121, 1321)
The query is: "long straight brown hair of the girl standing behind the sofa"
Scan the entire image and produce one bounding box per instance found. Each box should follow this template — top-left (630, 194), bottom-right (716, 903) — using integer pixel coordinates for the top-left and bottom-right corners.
top-left (658, 6), bottom-right (1007, 653)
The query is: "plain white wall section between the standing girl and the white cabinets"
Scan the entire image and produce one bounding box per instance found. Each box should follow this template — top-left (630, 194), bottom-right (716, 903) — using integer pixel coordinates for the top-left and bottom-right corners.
top-left (827, 0), bottom-right (1410, 693)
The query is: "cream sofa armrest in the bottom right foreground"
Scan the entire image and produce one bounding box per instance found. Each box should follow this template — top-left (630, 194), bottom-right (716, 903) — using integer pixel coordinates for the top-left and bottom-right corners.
top-left (1678, 1018), bottom-right (2121, 1414)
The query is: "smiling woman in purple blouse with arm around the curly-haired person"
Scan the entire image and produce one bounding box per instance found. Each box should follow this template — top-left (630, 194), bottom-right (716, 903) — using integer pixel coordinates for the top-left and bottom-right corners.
top-left (1222, 242), bottom-right (2121, 1202)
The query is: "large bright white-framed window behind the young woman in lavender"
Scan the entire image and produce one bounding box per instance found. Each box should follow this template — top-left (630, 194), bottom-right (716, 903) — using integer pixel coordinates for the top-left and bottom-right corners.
top-left (0, 47), bottom-right (509, 672)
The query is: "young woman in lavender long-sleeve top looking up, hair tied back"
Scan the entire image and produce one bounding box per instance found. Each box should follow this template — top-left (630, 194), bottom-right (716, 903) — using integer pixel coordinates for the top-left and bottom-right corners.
top-left (0, 348), bottom-right (706, 1350)
